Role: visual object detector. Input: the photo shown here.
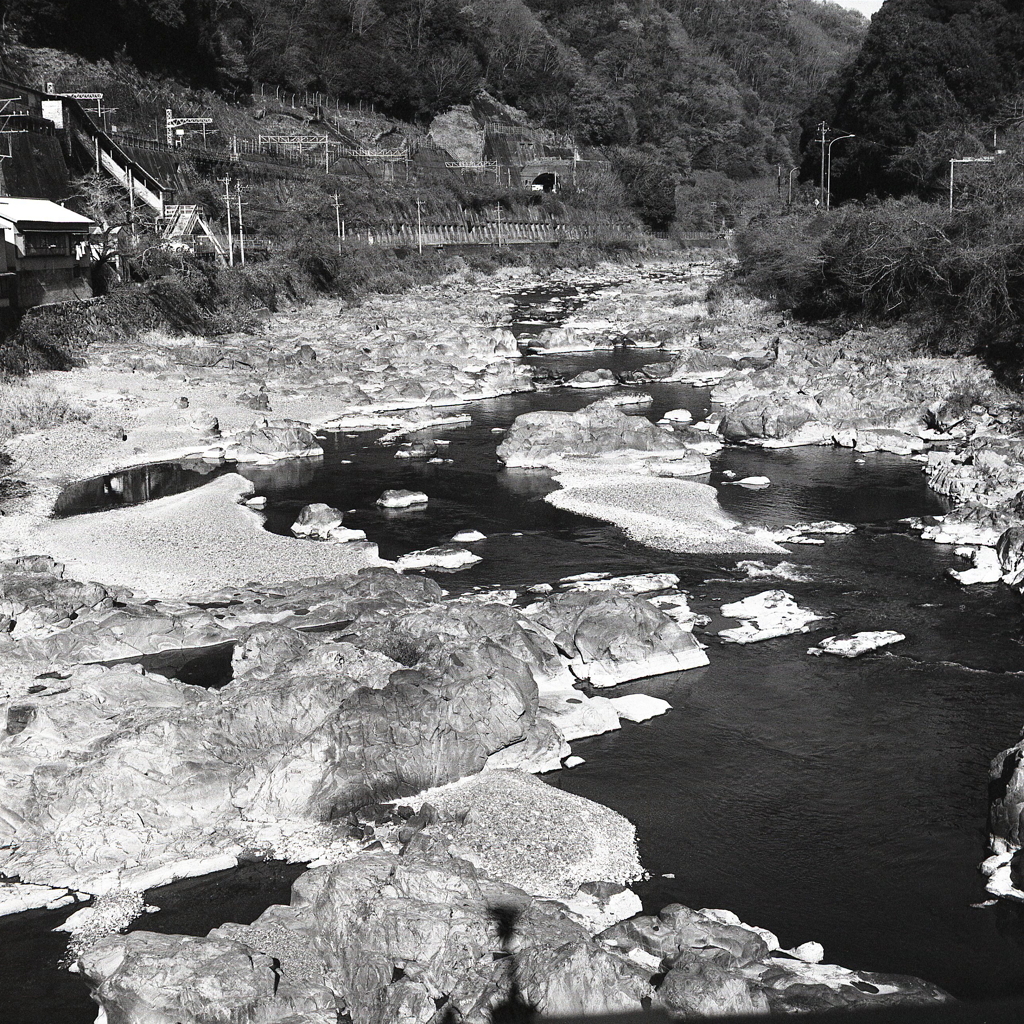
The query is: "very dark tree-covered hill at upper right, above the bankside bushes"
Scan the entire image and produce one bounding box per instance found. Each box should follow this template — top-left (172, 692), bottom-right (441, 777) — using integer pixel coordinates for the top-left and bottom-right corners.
top-left (804, 0), bottom-right (1024, 199)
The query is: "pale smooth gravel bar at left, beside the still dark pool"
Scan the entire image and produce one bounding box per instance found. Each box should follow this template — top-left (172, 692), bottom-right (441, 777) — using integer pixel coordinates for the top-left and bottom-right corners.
top-left (18, 473), bottom-right (382, 597)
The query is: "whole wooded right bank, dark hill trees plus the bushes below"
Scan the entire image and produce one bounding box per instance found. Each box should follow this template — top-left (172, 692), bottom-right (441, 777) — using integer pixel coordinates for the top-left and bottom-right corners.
top-left (739, 0), bottom-right (1024, 376)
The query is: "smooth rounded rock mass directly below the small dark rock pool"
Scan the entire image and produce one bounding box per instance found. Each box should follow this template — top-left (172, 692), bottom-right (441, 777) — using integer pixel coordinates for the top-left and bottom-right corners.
top-left (0, 618), bottom-right (537, 889)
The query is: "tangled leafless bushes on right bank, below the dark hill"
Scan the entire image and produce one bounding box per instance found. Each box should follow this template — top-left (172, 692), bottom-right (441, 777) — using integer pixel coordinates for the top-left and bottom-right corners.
top-left (737, 134), bottom-right (1024, 385)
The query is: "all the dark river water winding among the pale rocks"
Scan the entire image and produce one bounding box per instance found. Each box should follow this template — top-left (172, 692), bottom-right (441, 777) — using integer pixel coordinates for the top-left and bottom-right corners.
top-left (14, 286), bottom-right (1024, 1024)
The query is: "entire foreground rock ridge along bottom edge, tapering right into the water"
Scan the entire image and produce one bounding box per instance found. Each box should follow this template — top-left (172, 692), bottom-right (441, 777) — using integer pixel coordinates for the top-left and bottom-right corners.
top-left (80, 839), bottom-right (946, 1024)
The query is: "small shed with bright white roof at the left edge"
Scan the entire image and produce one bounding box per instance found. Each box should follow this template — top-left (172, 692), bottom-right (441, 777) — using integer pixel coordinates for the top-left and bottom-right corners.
top-left (0, 196), bottom-right (96, 309)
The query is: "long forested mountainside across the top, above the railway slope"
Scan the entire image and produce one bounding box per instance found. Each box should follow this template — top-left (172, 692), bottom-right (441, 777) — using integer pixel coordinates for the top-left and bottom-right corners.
top-left (3, 0), bottom-right (866, 197)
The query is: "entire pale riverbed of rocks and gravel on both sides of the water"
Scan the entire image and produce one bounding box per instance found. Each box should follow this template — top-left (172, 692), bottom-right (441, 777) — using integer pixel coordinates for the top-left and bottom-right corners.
top-left (6, 253), bottom-right (1024, 1024)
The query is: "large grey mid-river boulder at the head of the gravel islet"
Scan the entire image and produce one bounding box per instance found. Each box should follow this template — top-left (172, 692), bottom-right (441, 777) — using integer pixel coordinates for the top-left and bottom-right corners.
top-left (498, 400), bottom-right (684, 467)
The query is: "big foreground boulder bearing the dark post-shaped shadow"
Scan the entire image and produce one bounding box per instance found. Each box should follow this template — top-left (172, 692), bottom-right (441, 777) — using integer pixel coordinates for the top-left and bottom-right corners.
top-left (79, 843), bottom-right (652, 1024)
